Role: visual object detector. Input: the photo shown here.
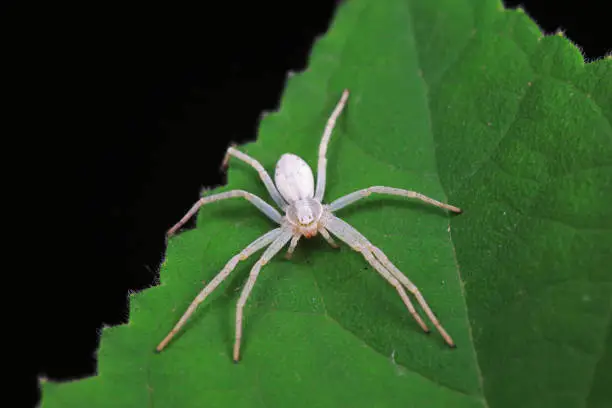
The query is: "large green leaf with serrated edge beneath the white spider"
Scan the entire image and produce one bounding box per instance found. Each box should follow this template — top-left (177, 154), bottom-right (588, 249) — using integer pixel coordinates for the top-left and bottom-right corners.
top-left (42, 0), bottom-right (612, 408)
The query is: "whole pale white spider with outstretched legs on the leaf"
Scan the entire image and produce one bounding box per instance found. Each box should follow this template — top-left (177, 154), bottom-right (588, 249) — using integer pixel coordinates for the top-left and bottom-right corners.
top-left (157, 90), bottom-right (461, 362)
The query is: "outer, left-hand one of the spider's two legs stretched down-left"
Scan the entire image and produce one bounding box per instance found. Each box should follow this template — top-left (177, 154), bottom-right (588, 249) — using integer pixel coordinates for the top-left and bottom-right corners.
top-left (156, 227), bottom-right (281, 352)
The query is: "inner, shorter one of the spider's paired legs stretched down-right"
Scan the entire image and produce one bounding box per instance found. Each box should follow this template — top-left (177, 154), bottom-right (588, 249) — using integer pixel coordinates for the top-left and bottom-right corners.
top-left (326, 217), bottom-right (429, 333)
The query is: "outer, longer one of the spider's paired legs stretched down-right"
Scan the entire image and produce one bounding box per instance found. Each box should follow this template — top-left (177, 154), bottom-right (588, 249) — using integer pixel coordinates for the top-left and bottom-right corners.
top-left (326, 214), bottom-right (455, 347)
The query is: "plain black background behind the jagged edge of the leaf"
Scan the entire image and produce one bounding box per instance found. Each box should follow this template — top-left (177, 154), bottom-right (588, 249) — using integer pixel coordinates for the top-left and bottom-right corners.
top-left (11, 0), bottom-right (612, 406)
